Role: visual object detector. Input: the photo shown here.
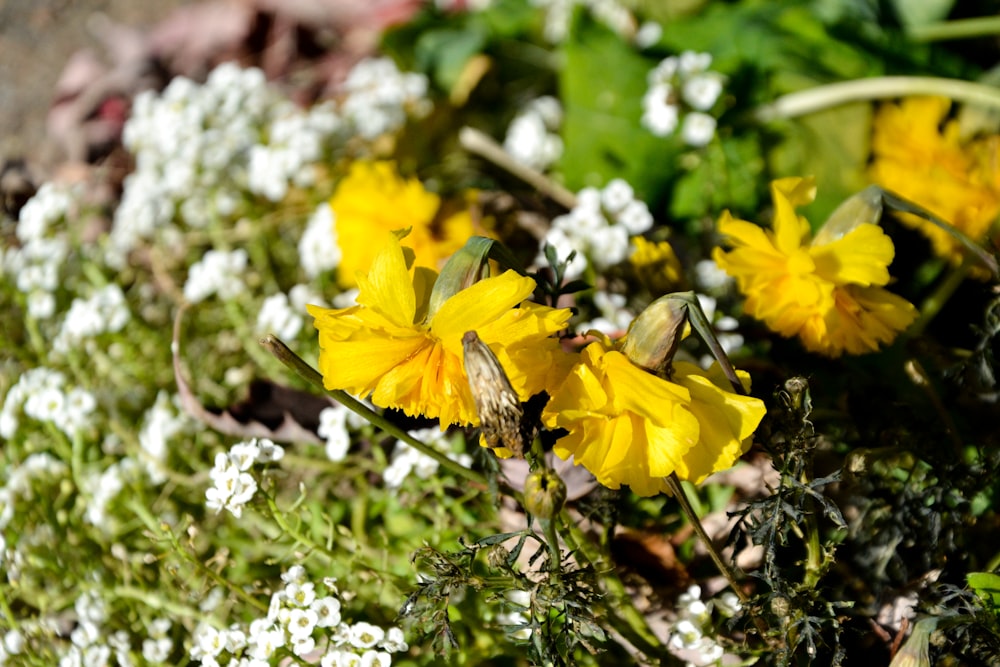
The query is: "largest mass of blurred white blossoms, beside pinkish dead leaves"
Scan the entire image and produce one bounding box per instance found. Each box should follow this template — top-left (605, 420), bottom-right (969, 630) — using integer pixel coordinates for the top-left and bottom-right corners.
top-left (107, 59), bottom-right (430, 266)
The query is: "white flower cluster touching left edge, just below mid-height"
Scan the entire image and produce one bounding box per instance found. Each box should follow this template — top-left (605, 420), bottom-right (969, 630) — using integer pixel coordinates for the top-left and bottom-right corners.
top-left (0, 367), bottom-right (97, 439)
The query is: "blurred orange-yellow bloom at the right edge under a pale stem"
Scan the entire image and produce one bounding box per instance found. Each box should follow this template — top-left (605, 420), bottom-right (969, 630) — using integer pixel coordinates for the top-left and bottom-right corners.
top-left (869, 97), bottom-right (1000, 263)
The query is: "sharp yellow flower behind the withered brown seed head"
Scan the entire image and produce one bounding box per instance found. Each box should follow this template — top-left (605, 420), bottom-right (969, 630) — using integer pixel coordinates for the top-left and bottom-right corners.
top-left (309, 237), bottom-right (570, 428)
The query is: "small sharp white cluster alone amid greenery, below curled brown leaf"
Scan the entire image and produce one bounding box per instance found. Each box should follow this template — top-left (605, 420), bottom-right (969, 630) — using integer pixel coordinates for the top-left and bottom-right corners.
top-left (205, 438), bottom-right (285, 518)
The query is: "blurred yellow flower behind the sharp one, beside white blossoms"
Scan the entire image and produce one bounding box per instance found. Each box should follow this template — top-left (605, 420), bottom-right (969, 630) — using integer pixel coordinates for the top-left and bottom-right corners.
top-left (330, 161), bottom-right (476, 287)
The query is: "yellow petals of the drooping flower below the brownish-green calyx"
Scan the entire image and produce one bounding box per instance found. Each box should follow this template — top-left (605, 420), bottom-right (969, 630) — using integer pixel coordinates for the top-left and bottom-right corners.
top-left (542, 340), bottom-right (765, 496)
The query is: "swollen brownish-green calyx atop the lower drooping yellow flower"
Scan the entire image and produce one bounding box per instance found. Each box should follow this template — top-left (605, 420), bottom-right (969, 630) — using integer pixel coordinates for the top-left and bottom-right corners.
top-left (621, 294), bottom-right (690, 377)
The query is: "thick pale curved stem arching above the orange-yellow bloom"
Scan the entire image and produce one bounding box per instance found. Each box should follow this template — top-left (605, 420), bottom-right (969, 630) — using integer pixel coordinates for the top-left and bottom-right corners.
top-left (750, 76), bottom-right (1000, 123)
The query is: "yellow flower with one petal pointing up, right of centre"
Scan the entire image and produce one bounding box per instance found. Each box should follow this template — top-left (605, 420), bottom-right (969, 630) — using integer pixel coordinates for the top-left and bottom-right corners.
top-left (712, 178), bottom-right (917, 357)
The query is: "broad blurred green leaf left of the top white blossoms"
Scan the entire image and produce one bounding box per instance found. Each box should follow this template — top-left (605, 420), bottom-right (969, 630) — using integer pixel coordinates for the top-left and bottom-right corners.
top-left (559, 16), bottom-right (676, 208)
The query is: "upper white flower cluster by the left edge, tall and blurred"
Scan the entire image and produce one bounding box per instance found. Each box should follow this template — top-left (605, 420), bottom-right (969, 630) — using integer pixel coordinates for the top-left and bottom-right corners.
top-left (0, 183), bottom-right (74, 320)
